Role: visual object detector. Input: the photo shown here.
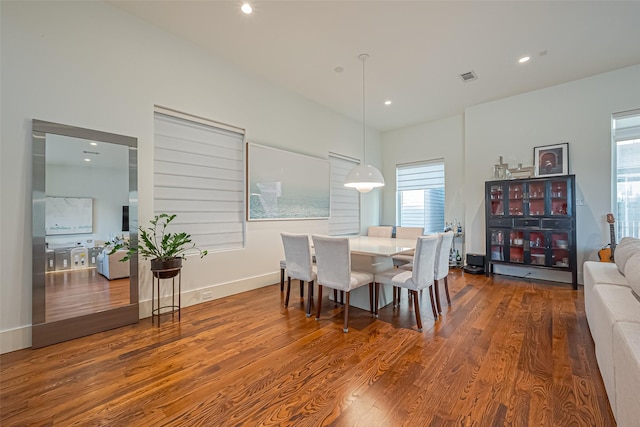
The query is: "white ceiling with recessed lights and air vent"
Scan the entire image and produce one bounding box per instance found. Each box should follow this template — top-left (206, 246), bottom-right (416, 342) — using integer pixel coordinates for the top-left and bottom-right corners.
top-left (109, 0), bottom-right (640, 131)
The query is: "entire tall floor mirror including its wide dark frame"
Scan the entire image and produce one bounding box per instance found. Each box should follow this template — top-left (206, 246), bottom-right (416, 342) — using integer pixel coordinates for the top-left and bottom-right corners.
top-left (32, 120), bottom-right (139, 348)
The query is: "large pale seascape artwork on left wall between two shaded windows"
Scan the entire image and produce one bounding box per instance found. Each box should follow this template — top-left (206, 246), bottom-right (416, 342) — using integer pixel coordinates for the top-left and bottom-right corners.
top-left (247, 143), bottom-right (331, 221)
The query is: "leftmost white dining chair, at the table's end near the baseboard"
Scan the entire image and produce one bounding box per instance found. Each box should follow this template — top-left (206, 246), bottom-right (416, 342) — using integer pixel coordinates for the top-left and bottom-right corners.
top-left (280, 233), bottom-right (317, 317)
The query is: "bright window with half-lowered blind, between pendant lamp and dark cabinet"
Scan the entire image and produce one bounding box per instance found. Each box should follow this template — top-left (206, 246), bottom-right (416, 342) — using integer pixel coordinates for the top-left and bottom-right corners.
top-left (396, 160), bottom-right (444, 233)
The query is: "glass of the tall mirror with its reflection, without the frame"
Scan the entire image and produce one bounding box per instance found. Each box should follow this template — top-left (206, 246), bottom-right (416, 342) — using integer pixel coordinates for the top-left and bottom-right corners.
top-left (45, 134), bottom-right (130, 322)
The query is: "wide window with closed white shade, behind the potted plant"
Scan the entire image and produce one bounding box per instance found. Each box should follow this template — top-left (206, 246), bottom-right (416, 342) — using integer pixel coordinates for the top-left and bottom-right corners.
top-left (153, 107), bottom-right (245, 251)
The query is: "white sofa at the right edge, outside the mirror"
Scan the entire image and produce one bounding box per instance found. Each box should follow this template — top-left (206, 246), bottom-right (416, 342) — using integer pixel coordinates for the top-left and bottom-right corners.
top-left (584, 237), bottom-right (640, 427)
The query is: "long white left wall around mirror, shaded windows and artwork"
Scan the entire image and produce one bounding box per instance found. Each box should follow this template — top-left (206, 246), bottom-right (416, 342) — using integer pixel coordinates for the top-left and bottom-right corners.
top-left (0, 1), bottom-right (381, 352)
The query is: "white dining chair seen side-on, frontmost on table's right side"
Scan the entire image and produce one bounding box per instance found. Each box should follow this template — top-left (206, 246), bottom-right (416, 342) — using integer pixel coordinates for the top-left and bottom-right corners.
top-left (374, 235), bottom-right (442, 331)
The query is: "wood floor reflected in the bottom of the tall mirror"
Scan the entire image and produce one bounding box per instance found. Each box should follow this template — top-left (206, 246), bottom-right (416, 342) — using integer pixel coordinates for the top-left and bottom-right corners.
top-left (45, 268), bottom-right (129, 322)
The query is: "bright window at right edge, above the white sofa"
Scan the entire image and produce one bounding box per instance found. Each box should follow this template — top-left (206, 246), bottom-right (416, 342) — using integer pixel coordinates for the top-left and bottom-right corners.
top-left (613, 110), bottom-right (640, 240)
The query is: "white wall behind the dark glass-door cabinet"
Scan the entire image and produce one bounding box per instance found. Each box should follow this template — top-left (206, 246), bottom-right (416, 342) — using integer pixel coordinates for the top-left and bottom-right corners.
top-left (465, 66), bottom-right (640, 283)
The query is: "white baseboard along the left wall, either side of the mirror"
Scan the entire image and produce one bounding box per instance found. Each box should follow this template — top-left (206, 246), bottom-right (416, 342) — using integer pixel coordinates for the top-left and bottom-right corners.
top-left (0, 272), bottom-right (280, 354)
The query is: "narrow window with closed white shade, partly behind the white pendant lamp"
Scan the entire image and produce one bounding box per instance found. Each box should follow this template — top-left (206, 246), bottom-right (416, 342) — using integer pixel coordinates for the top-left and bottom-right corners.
top-left (329, 153), bottom-right (360, 236)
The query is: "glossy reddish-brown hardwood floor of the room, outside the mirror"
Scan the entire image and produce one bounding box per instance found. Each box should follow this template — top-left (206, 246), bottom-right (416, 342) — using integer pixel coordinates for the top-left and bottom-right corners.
top-left (0, 270), bottom-right (615, 427)
